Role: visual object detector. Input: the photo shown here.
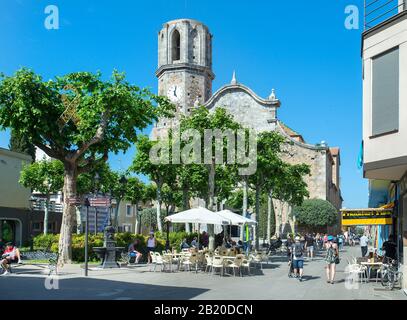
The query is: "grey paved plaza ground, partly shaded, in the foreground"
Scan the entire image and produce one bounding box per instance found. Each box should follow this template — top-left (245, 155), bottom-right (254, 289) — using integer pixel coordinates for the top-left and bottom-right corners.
top-left (0, 247), bottom-right (407, 300)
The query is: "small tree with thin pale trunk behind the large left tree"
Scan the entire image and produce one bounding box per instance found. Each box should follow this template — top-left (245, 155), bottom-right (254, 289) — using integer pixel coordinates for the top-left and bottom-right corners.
top-left (19, 160), bottom-right (64, 234)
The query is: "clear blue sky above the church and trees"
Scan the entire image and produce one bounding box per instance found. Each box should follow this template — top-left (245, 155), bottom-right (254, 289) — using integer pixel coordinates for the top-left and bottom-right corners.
top-left (0, 0), bottom-right (368, 208)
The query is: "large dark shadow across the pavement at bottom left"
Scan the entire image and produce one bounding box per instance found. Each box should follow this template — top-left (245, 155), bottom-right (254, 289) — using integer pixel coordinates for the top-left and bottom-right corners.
top-left (0, 276), bottom-right (208, 300)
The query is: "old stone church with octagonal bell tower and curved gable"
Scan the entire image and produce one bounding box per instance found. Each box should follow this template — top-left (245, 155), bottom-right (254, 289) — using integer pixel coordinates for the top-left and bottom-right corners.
top-left (151, 19), bottom-right (342, 233)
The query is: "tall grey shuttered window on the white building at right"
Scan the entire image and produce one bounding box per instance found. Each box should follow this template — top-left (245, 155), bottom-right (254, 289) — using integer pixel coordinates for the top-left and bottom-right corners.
top-left (372, 47), bottom-right (399, 136)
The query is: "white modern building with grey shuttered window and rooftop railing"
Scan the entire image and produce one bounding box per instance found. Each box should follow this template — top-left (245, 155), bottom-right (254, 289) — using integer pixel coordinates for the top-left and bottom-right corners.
top-left (362, 0), bottom-right (407, 288)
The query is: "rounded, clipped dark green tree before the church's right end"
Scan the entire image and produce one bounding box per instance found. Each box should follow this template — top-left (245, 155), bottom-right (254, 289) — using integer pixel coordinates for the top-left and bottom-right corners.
top-left (292, 199), bottom-right (338, 230)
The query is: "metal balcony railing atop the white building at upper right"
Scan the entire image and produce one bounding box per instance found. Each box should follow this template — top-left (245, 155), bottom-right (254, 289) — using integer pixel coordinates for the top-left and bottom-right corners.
top-left (364, 0), bottom-right (407, 30)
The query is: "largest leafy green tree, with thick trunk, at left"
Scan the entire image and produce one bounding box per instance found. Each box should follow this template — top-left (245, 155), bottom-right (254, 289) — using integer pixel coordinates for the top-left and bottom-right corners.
top-left (0, 69), bottom-right (173, 263)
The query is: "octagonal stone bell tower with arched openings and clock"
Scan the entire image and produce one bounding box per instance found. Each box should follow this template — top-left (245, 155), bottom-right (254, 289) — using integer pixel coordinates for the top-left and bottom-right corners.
top-left (153, 19), bottom-right (215, 136)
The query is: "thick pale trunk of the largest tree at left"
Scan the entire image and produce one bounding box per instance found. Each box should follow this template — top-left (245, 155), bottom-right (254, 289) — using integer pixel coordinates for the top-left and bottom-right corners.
top-left (58, 163), bottom-right (78, 265)
